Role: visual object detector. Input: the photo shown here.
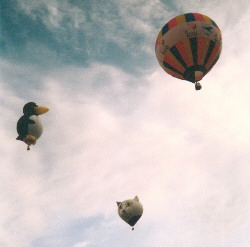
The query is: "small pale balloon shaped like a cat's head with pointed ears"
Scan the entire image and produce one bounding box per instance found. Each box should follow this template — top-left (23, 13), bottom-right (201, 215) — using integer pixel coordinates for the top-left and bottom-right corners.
top-left (116, 196), bottom-right (143, 230)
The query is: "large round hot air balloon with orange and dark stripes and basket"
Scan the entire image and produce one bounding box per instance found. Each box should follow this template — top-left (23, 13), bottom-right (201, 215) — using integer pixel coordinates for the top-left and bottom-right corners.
top-left (155, 13), bottom-right (222, 90)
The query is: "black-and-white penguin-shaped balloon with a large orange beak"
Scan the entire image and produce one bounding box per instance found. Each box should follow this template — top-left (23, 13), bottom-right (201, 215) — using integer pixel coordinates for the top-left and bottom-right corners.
top-left (16, 102), bottom-right (49, 150)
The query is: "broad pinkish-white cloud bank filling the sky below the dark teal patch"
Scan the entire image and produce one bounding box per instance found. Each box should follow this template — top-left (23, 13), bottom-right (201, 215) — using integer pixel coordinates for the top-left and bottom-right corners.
top-left (0, 1), bottom-right (250, 247)
